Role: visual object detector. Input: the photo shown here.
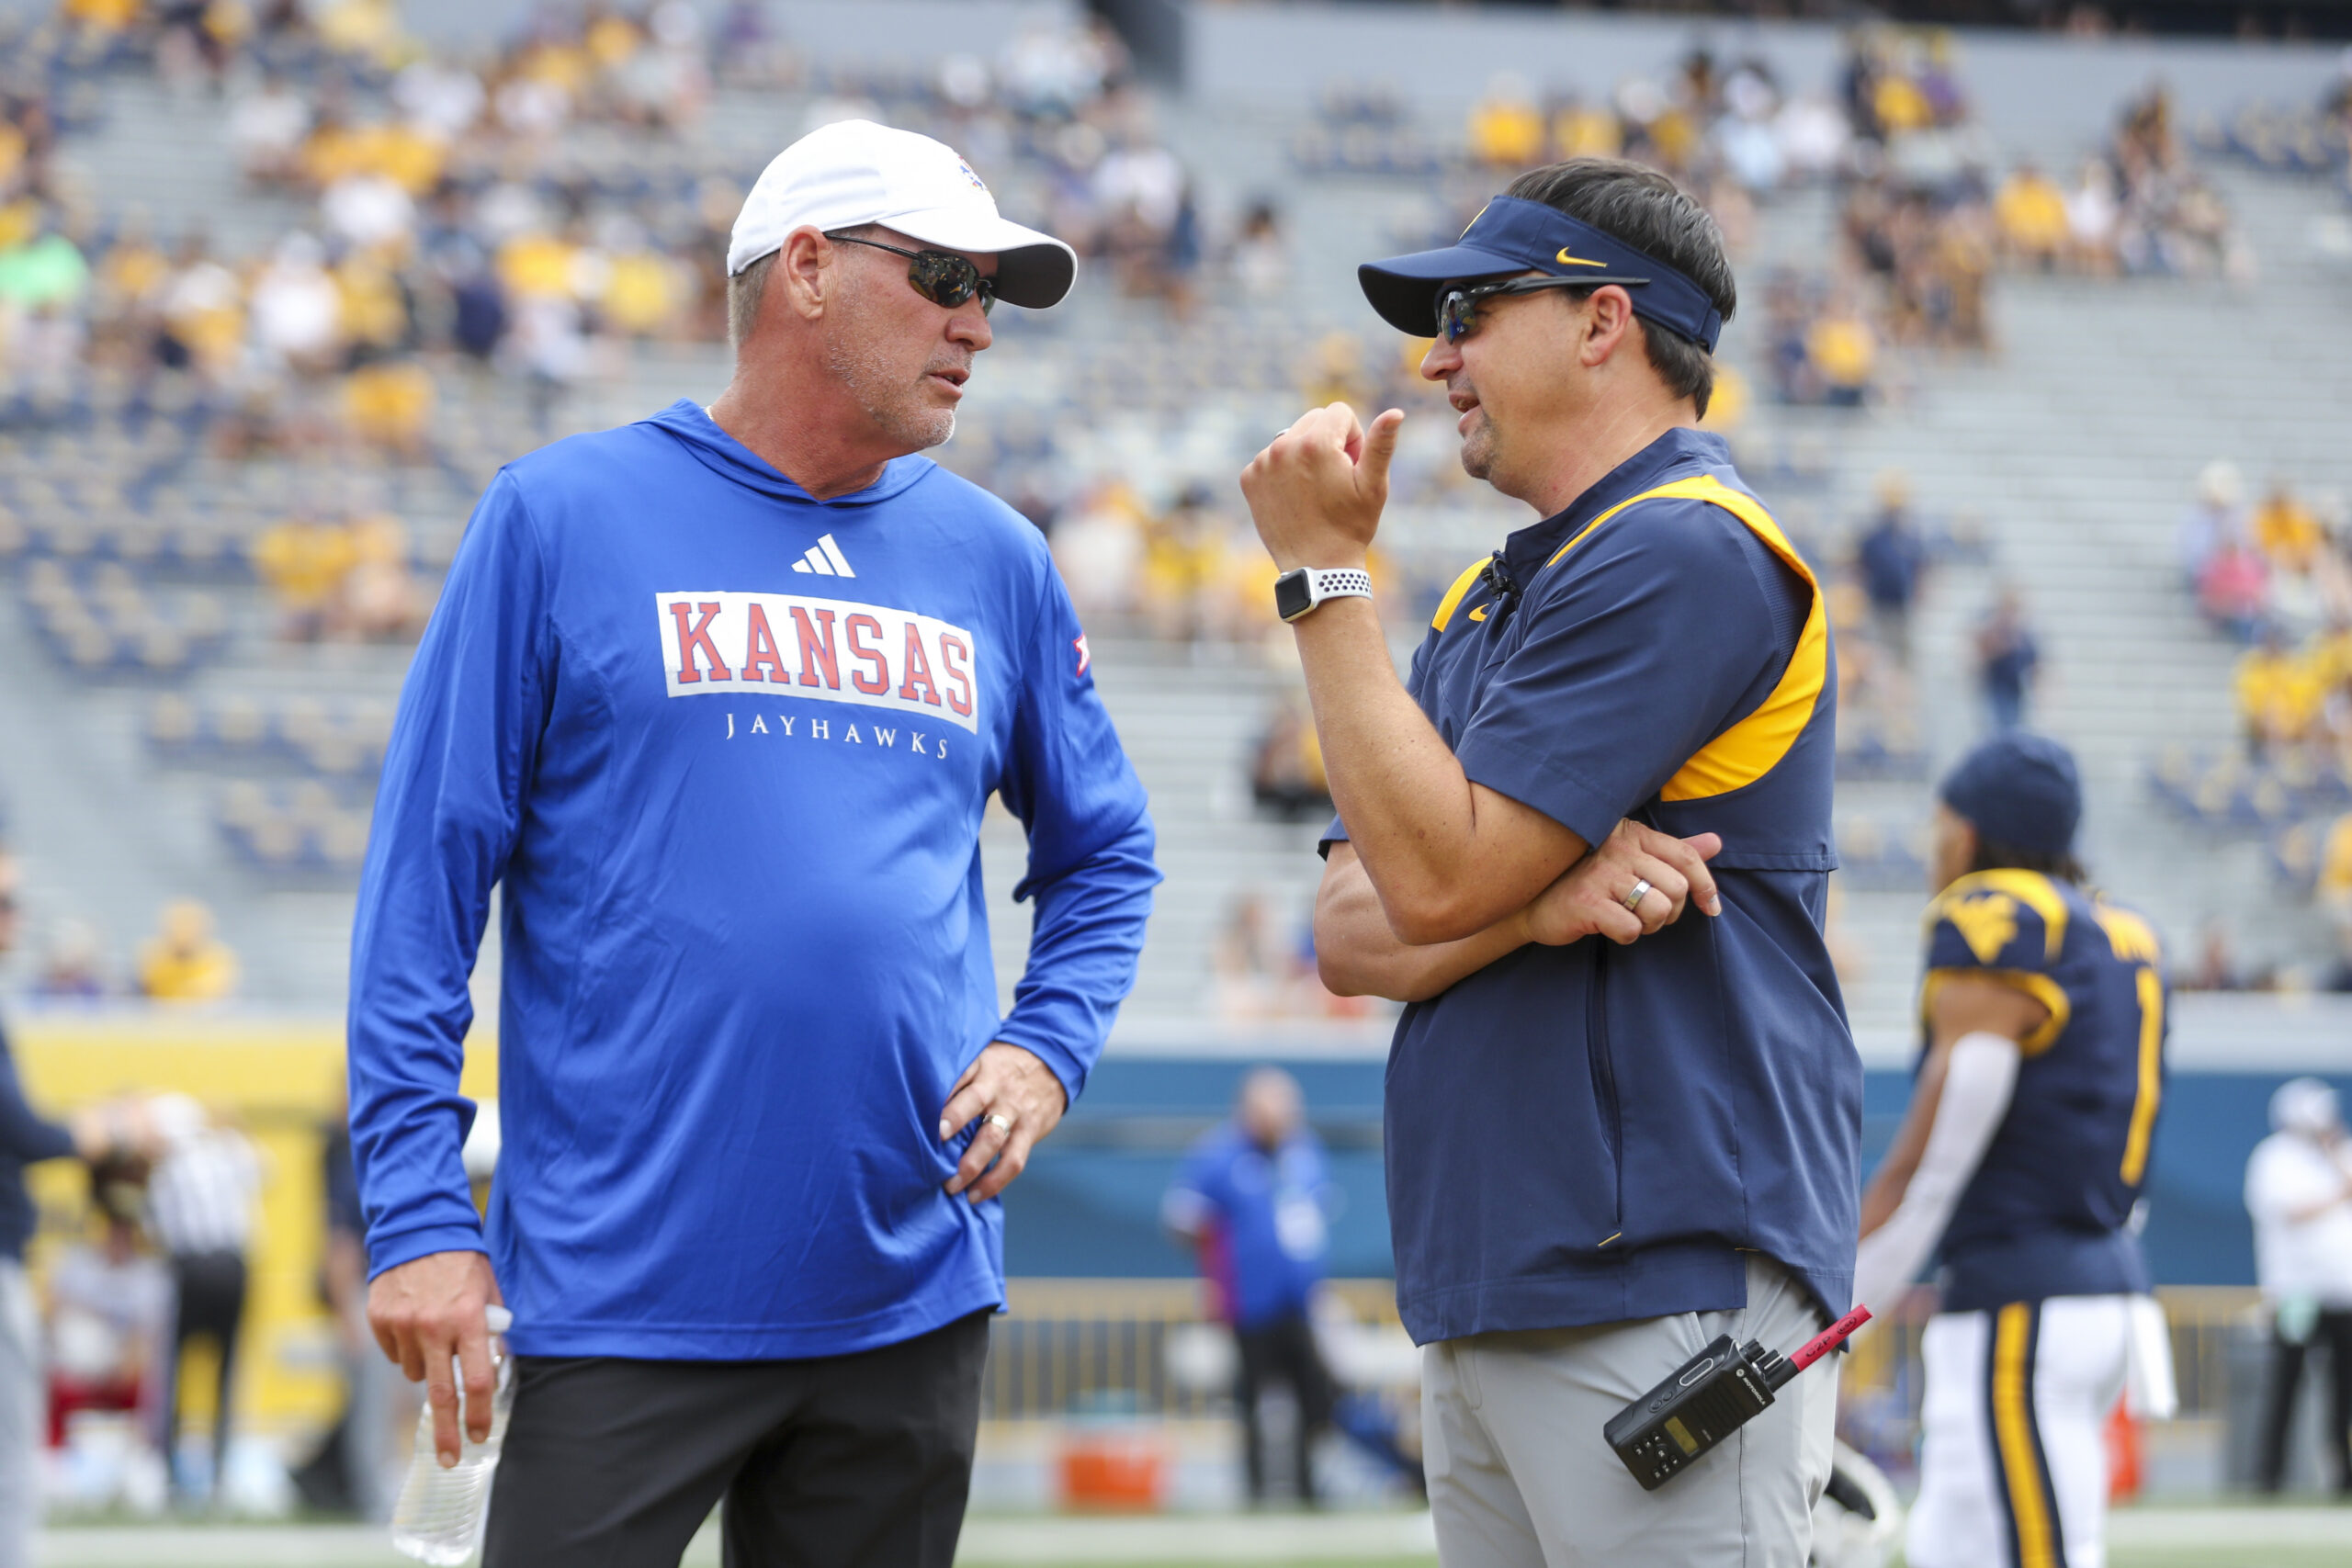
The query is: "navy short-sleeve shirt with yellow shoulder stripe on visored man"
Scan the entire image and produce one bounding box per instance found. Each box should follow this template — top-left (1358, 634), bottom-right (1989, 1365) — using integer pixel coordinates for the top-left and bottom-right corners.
top-left (1331, 430), bottom-right (1863, 1342)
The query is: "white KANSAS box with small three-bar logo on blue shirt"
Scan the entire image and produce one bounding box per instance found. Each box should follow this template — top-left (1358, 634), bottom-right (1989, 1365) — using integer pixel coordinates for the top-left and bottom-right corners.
top-left (654, 592), bottom-right (981, 733)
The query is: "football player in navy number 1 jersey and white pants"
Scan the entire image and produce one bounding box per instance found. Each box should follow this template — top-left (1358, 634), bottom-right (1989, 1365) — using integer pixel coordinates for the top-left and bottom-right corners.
top-left (1853, 731), bottom-right (2171, 1568)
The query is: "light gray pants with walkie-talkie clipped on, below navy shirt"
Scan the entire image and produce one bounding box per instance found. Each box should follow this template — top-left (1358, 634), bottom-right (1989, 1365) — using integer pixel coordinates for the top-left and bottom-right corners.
top-left (1420, 1253), bottom-right (1837, 1568)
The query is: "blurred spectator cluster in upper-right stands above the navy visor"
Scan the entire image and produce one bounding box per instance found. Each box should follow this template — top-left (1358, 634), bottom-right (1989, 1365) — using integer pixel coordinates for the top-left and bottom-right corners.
top-left (1430, 39), bottom-right (2253, 425)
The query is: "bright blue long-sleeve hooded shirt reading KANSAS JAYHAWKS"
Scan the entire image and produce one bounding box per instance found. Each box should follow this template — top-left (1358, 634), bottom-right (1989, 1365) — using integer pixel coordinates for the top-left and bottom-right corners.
top-left (350, 402), bottom-right (1158, 1359)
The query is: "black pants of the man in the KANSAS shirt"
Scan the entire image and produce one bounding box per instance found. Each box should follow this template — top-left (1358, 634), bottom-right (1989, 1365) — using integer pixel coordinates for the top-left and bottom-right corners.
top-left (482, 1312), bottom-right (988, 1568)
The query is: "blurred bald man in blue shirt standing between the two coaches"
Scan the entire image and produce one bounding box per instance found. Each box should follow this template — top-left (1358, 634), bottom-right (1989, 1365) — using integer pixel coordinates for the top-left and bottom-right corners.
top-left (1162, 1067), bottom-right (1331, 1505)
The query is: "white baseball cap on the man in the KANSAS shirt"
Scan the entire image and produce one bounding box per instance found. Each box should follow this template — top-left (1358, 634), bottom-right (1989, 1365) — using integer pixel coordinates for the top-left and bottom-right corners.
top-left (727, 120), bottom-right (1077, 310)
